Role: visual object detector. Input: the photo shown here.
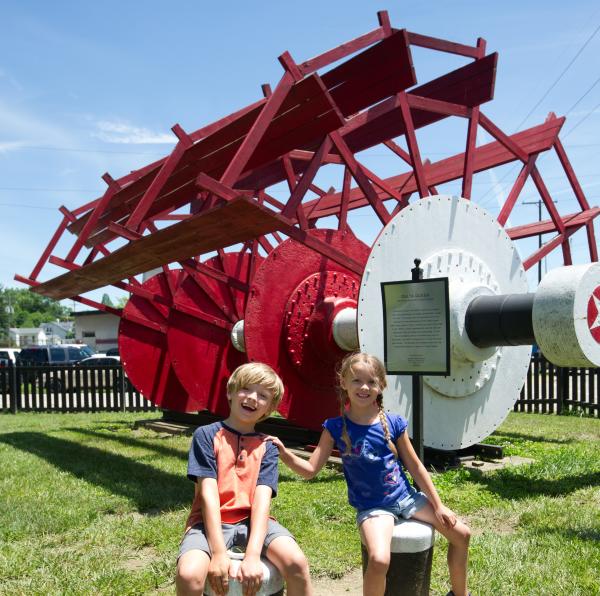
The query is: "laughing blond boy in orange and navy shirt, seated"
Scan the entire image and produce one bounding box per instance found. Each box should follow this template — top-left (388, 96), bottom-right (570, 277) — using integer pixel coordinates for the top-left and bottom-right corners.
top-left (176, 362), bottom-right (312, 596)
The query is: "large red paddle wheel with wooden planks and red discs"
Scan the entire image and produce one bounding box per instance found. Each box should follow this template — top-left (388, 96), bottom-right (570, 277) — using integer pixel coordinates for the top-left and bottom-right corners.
top-left (16, 12), bottom-right (598, 428)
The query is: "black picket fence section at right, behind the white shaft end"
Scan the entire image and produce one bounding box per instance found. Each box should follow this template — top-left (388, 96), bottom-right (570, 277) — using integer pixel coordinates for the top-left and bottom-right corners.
top-left (514, 353), bottom-right (600, 417)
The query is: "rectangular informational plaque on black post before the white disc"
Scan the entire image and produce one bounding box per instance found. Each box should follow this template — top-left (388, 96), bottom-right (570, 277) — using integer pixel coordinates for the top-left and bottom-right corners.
top-left (381, 277), bottom-right (450, 375)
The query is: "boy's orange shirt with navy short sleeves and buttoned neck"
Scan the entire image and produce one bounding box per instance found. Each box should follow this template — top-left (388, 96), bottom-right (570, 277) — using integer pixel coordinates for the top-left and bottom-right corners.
top-left (186, 422), bottom-right (279, 528)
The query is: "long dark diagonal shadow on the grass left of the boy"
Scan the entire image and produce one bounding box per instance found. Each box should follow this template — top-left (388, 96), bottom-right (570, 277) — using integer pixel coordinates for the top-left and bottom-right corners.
top-left (0, 432), bottom-right (194, 513)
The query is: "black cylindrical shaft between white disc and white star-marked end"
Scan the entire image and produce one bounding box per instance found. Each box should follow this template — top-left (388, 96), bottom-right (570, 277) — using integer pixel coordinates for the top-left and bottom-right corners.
top-left (465, 294), bottom-right (535, 348)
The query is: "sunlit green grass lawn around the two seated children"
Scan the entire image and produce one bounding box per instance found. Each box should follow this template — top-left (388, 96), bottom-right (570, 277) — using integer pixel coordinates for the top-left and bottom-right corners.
top-left (0, 413), bottom-right (600, 596)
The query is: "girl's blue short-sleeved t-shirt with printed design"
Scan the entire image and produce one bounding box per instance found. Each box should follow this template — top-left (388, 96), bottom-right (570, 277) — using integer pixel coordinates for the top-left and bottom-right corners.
top-left (323, 413), bottom-right (415, 511)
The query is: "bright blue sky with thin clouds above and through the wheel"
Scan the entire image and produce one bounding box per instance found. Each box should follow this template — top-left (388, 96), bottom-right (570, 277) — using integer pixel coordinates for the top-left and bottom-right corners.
top-left (0, 0), bottom-right (600, 308)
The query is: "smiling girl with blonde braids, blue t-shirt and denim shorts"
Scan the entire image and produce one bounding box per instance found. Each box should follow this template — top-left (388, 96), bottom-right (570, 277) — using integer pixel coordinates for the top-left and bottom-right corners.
top-left (272, 353), bottom-right (471, 596)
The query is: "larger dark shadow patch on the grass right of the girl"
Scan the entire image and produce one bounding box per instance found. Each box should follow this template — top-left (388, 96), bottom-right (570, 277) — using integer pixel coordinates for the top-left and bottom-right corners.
top-left (467, 469), bottom-right (600, 500)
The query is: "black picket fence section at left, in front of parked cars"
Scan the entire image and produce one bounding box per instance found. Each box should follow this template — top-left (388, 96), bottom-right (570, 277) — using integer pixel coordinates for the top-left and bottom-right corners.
top-left (0, 364), bottom-right (158, 412)
